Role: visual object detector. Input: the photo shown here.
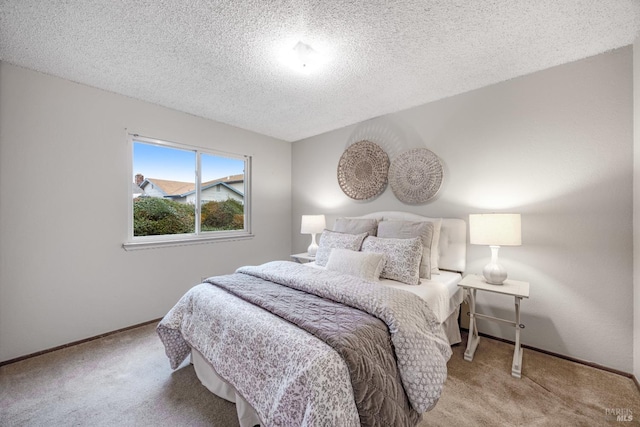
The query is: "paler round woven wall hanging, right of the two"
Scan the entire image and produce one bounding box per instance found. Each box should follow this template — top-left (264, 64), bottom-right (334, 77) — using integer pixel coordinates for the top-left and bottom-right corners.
top-left (389, 148), bottom-right (444, 204)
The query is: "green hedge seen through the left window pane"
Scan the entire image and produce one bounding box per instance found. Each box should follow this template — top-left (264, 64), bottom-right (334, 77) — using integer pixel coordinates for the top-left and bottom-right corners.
top-left (133, 197), bottom-right (195, 236)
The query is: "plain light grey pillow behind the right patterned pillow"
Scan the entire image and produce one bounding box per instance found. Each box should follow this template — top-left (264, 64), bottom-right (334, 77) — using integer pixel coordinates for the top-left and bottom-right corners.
top-left (378, 220), bottom-right (437, 279)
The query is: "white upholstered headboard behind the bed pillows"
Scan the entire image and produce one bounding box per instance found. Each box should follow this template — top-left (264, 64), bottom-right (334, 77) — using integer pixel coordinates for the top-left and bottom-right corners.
top-left (350, 211), bottom-right (467, 273)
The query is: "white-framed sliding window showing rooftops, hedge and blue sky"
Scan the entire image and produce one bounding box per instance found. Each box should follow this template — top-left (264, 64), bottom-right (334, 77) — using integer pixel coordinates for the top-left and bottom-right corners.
top-left (124, 134), bottom-right (251, 249)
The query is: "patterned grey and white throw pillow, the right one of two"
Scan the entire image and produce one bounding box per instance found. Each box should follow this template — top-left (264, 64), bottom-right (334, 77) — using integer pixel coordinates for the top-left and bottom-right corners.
top-left (362, 237), bottom-right (422, 285)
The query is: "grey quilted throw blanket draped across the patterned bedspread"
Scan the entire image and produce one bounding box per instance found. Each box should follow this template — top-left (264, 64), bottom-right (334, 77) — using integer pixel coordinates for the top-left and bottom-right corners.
top-left (207, 274), bottom-right (421, 427)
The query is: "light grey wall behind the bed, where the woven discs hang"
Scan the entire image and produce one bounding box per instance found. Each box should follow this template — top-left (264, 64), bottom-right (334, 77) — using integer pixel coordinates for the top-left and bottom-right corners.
top-left (291, 47), bottom-right (633, 372)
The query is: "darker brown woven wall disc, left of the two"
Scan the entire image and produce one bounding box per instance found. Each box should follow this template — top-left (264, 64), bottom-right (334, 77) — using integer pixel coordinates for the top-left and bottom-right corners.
top-left (338, 141), bottom-right (389, 200)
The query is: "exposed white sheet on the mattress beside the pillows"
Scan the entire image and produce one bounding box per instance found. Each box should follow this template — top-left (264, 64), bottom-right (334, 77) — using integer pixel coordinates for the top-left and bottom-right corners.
top-left (304, 262), bottom-right (463, 323)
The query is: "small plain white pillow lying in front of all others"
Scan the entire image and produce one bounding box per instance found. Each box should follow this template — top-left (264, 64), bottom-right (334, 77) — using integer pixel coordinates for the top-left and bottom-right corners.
top-left (326, 248), bottom-right (385, 282)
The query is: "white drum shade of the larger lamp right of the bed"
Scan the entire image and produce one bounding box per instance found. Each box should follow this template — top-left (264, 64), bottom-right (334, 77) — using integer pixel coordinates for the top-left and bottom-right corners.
top-left (469, 213), bottom-right (522, 246)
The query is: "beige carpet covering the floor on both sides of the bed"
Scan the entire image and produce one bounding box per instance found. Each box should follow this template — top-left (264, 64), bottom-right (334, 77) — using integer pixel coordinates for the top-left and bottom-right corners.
top-left (0, 325), bottom-right (640, 427)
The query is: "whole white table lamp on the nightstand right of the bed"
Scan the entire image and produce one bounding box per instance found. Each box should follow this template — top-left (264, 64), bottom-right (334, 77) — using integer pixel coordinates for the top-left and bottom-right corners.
top-left (469, 213), bottom-right (522, 285)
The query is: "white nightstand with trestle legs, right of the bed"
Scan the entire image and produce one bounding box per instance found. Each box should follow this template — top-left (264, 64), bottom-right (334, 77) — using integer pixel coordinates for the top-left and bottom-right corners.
top-left (458, 274), bottom-right (529, 378)
